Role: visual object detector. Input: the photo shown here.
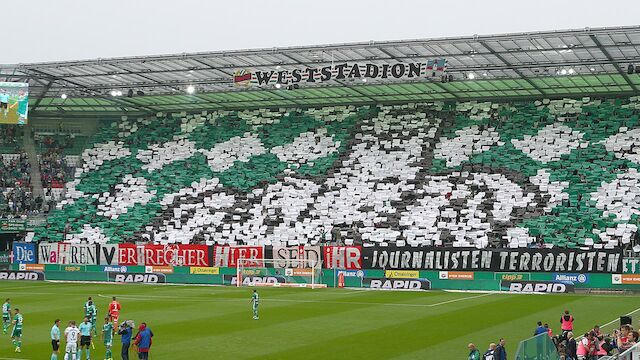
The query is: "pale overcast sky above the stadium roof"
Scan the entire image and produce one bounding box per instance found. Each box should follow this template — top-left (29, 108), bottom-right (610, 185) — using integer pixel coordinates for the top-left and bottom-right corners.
top-left (5, 0), bottom-right (640, 64)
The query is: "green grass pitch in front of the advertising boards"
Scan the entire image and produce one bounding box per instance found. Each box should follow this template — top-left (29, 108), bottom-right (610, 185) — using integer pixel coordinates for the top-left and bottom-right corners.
top-left (0, 282), bottom-right (640, 360)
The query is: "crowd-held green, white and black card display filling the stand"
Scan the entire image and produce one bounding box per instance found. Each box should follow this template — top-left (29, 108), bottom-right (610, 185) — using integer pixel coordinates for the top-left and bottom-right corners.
top-left (32, 97), bottom-right (640, 248)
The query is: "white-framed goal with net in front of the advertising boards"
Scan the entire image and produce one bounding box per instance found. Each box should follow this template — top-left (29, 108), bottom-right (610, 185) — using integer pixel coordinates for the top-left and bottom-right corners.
top-left (235, 259), bottom-right (327, 289)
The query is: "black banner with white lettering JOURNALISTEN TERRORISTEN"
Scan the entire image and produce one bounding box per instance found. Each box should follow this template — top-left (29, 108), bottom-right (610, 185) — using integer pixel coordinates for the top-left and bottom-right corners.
top-left (362, 247), bottom-right (622, 273)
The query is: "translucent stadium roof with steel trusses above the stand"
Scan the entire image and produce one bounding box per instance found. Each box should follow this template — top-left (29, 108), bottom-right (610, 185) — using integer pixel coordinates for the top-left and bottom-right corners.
top-left (0, 26), bottom-right (640, 116)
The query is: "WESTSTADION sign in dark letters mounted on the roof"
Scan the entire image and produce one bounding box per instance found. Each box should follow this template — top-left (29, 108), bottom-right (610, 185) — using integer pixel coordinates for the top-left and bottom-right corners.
top-left (233, 59), bottom-right (447, 87)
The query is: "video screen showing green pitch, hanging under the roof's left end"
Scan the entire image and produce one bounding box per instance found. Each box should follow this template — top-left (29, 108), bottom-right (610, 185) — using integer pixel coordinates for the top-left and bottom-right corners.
top-left (0, 82), bottom-right (29, 124)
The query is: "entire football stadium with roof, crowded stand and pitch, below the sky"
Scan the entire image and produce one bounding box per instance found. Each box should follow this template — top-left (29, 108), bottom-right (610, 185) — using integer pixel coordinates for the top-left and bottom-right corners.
top-left (0, 1), bottom-right (640, 360)
